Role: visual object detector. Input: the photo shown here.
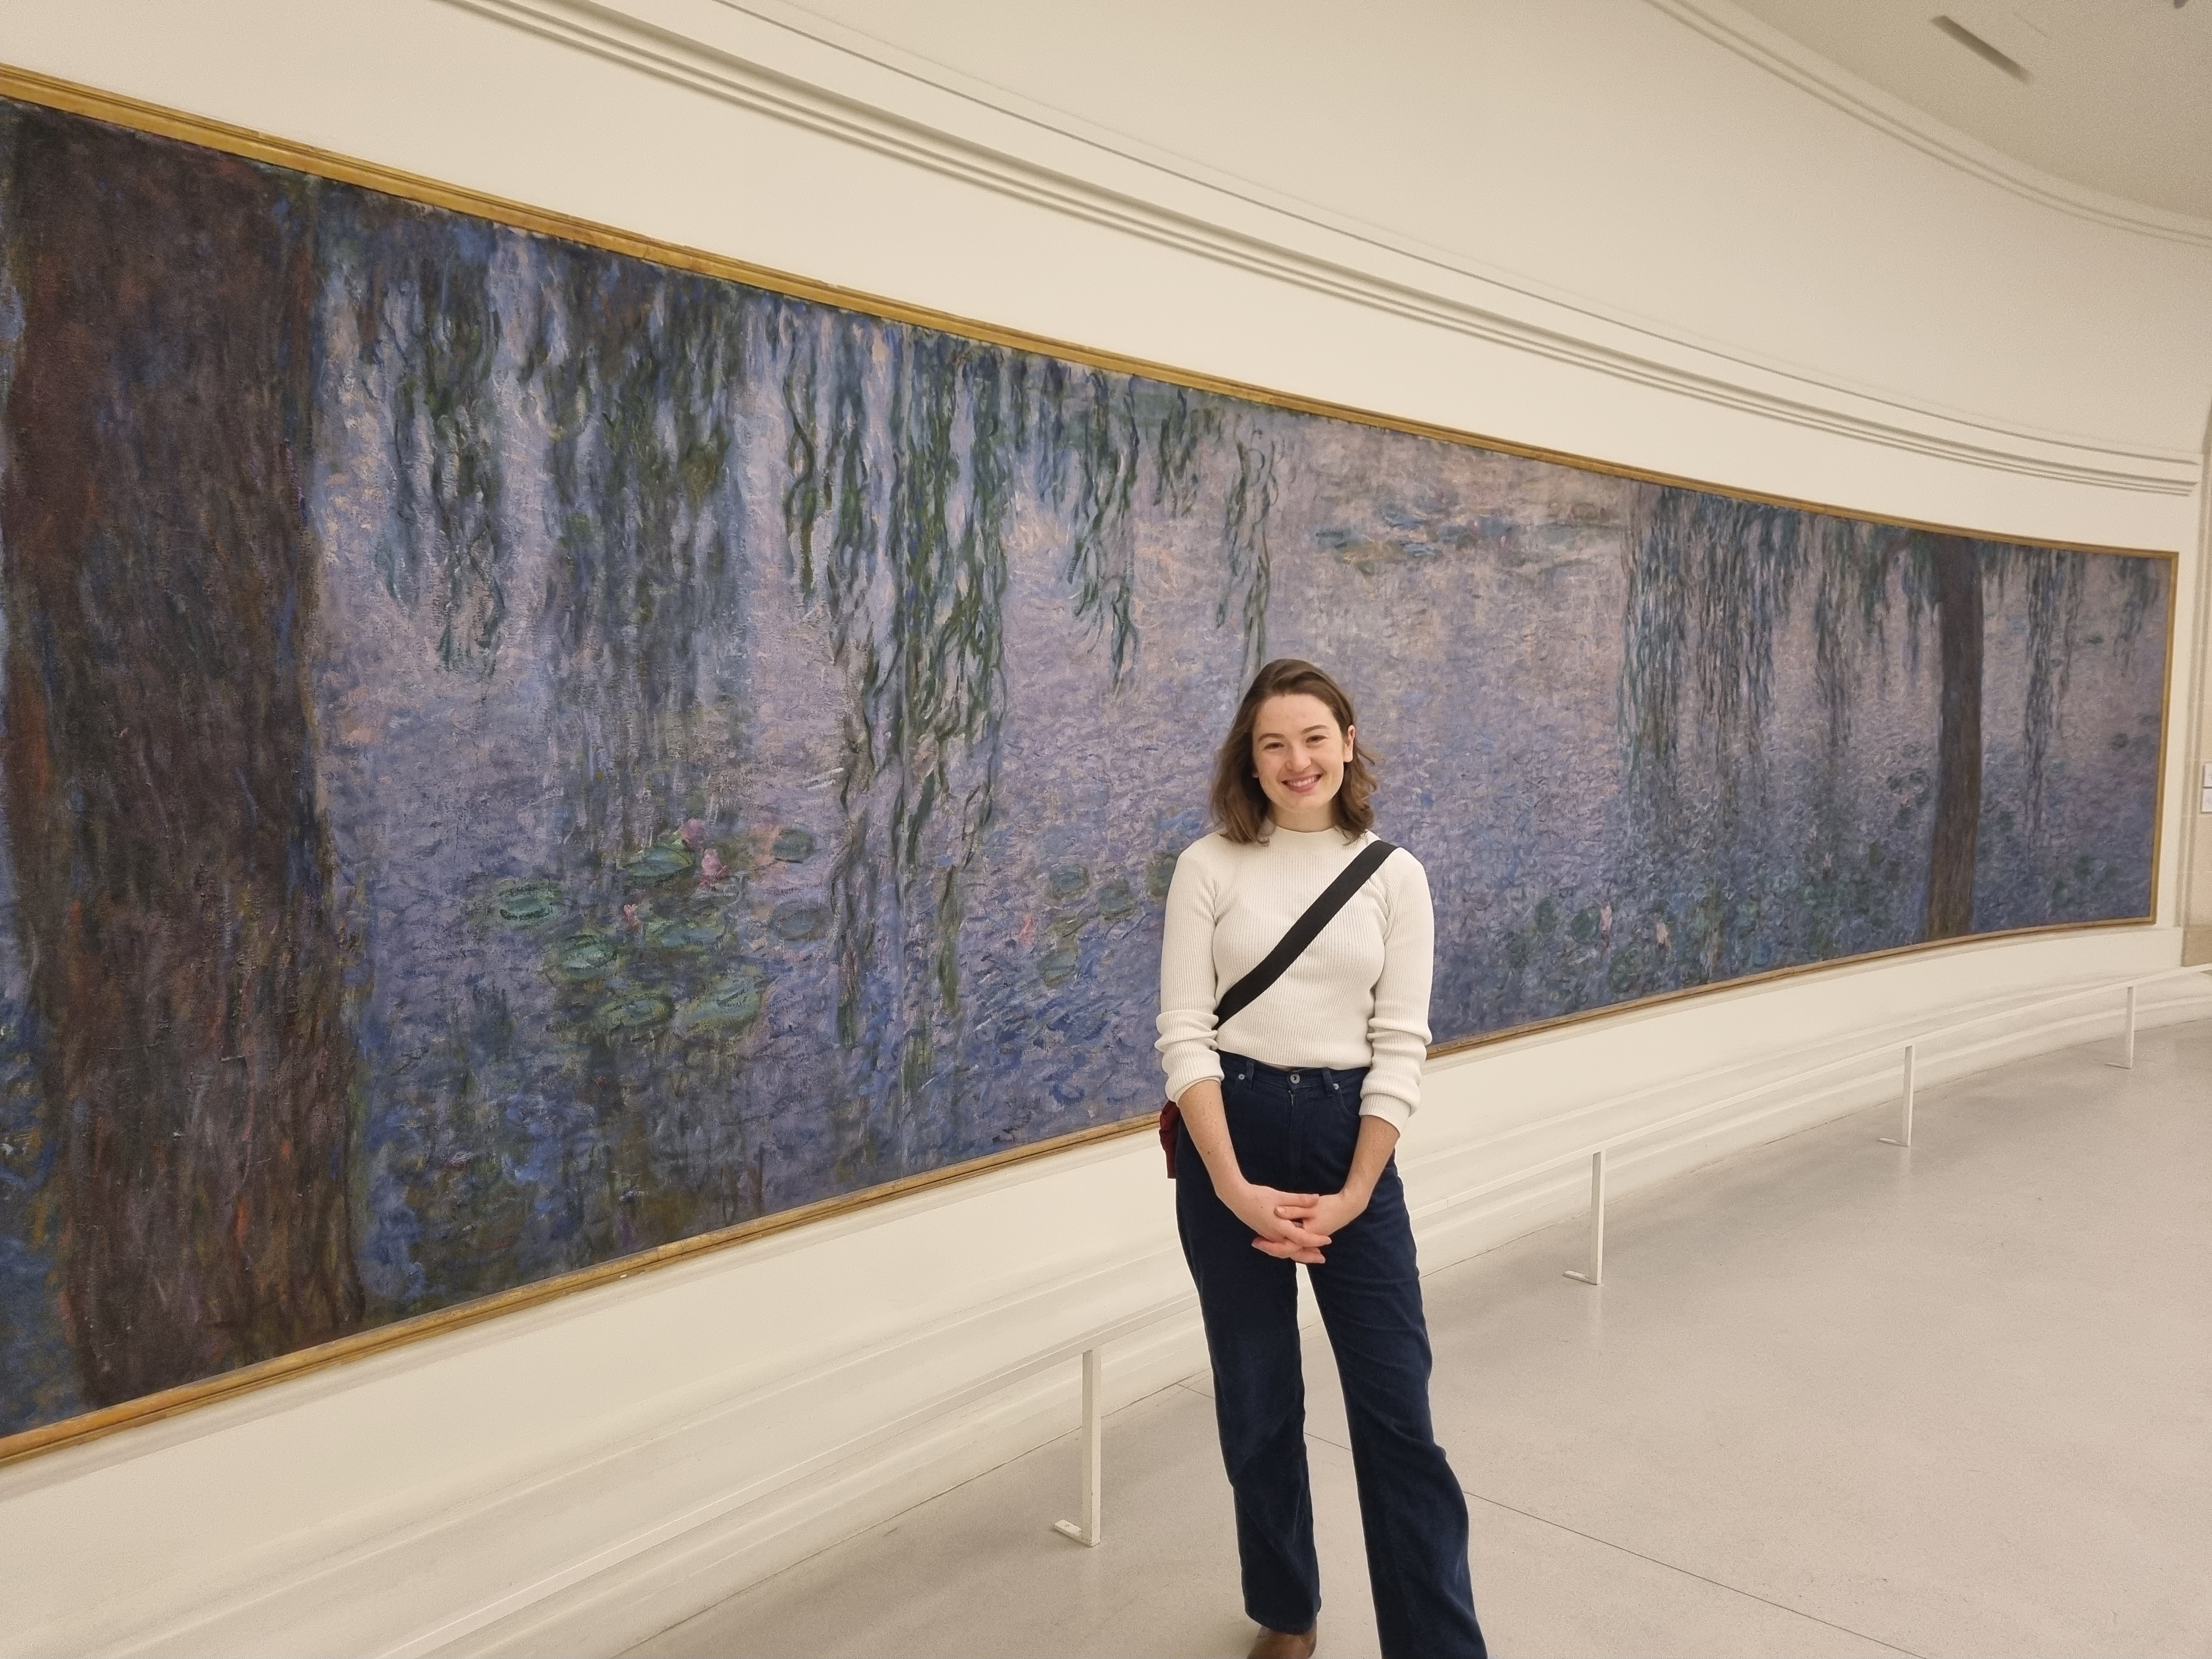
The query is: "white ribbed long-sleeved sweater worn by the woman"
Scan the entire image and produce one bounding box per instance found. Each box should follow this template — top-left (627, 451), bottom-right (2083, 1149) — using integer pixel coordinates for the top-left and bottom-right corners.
top-left (1157, 830), bottom-right (1436, 1130)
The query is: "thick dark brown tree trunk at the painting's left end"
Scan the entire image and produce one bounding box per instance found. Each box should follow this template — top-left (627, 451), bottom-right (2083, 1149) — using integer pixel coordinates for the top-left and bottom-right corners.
top-left (0, 113), bottom-right (361, 1405)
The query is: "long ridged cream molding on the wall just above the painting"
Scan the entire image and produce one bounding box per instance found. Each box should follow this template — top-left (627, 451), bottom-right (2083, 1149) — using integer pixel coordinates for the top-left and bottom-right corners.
top-left (447, 0), bottom-right (2199, 495)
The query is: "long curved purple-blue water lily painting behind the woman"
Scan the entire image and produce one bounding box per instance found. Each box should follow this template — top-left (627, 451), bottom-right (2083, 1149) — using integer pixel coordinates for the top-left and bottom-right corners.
top-left (0, 88), bottom-right (2172, 1433)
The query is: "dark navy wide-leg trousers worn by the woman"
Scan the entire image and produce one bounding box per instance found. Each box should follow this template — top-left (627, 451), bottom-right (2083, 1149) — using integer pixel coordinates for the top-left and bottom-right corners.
top-left (1175, 1055), bottom-right (1484, 1659)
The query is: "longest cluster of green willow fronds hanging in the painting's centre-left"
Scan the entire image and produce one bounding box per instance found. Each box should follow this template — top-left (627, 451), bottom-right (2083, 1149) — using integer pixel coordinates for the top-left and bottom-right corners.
top-left (776, 312), bottom-right (1020, 1119)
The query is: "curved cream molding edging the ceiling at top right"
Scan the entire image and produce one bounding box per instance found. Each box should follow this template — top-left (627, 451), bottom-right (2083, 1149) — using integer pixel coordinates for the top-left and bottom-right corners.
top-left (1646, 0), bottom-right (2212, 248)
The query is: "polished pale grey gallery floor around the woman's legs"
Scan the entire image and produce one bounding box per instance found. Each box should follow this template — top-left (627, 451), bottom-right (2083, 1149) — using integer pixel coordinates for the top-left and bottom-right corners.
top-left (633, 1024), bottom-right (2212, 1659)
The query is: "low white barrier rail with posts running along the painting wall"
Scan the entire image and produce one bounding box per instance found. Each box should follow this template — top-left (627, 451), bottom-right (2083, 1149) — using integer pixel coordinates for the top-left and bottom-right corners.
top-left (1035, 962), bottom-right (2212, 1546)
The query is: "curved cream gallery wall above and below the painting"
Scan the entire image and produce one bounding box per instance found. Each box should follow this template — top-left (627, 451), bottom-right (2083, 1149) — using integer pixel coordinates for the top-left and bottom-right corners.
top-left (0, 0), bottom-right (2212, 1655)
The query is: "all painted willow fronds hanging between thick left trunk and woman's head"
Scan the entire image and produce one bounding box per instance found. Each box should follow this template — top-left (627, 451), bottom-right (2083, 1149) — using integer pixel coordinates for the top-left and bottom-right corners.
top-left (332, 226), bottom-right (1281, 1152)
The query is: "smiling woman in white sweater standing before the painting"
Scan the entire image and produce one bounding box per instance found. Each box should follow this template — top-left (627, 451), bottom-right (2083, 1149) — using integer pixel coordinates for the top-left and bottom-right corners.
top-left (1159, 657), bottom-right (1484, 1659)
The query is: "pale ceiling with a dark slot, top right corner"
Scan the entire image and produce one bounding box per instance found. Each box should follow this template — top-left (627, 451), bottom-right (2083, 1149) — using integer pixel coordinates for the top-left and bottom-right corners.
top-left (1736, 0), bottom-right (2212, 219)
